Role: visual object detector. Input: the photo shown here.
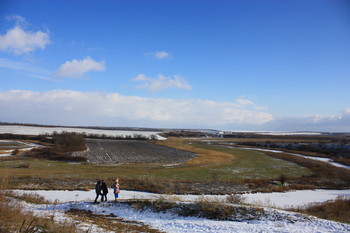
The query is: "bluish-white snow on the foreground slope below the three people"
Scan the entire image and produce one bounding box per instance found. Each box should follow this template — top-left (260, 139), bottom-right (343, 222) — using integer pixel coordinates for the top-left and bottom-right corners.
top-left (10, 191), bottom-right (350, 233)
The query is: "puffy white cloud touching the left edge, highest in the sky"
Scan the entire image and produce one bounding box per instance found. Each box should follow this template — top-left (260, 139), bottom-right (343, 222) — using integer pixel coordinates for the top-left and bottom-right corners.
top-left (0, 21), bottom-right (51, 55)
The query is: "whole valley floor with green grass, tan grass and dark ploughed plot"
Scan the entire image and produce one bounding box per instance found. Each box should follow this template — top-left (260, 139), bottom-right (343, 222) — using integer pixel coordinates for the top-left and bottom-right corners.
top-left (0, 128), bottom-right (350, 193)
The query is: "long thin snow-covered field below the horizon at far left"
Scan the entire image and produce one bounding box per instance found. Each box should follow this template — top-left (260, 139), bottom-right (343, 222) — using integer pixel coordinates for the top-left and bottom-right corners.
top-left (0, 125), bottom-right (165, 140)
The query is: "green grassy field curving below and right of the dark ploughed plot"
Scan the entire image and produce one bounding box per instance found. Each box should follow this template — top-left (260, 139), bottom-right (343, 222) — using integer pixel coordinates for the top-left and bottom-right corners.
top-left (0, 143), bottom-right (311, 185)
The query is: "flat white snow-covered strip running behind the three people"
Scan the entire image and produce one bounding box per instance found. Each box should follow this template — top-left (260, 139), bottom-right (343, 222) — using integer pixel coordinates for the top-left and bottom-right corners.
top-left (16, 189), bottom-right (350, 208)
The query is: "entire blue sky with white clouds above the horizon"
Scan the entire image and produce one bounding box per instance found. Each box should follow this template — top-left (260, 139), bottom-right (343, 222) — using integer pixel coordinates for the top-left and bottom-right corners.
top-left (0, 0), bottom-right (350, 131)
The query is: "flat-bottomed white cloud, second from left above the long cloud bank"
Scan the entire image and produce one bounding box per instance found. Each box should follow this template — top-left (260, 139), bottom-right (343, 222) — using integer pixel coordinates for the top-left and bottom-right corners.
top-left (55, 57), bottom-right (105, 78)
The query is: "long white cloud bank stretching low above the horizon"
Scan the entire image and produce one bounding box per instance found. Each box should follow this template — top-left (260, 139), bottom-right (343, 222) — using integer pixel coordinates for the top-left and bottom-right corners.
top-left (0, 90), bottom-right (273, 128)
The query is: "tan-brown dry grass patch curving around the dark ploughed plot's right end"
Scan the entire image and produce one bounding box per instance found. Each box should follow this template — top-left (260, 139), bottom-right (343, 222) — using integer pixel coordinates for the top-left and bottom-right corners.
top-left (155, 137), bottom-right (235, 165)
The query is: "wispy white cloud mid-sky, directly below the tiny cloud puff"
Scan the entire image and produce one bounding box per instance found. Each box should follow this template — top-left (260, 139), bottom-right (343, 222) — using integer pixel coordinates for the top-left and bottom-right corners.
top-left (132, 74), bottom-right (192, 91)
